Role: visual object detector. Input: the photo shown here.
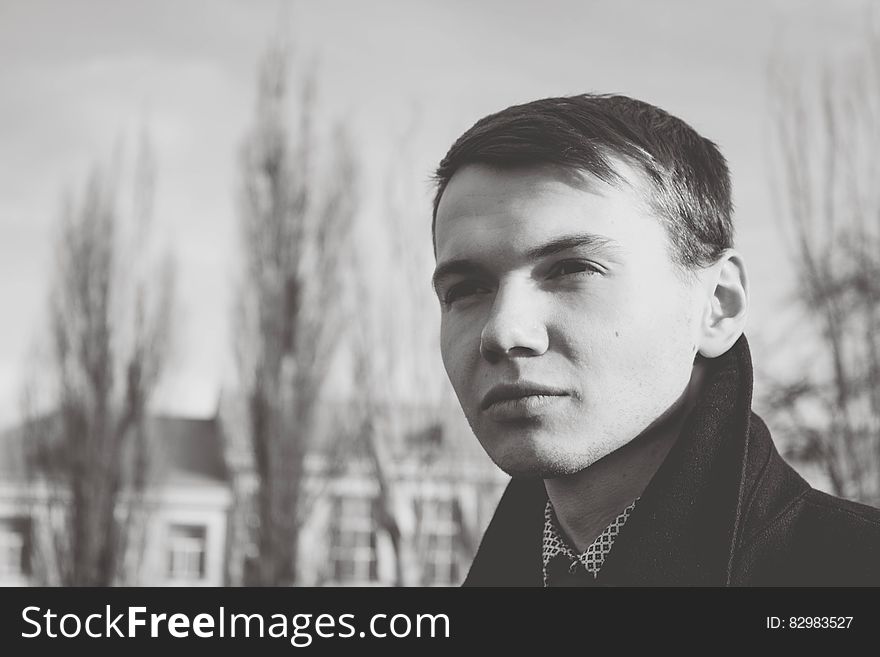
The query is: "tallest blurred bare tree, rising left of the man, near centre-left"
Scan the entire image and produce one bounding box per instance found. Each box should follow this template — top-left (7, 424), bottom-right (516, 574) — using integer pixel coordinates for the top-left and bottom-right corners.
top-left (236, 47), bottom-right (357, 585)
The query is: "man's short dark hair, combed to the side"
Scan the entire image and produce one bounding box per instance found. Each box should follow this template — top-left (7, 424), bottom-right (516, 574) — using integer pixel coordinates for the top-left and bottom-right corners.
top-left (431, 94), bottom-right (733, 270)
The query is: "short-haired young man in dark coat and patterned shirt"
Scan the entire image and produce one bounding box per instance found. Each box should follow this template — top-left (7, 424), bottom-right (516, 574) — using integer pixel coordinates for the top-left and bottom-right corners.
top-left (433, 95), bottom-right (880, 586)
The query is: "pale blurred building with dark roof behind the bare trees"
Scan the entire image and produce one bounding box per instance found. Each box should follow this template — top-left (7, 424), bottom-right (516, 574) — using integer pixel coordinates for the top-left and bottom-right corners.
top-left (0, 399), bottom-right (507, 586)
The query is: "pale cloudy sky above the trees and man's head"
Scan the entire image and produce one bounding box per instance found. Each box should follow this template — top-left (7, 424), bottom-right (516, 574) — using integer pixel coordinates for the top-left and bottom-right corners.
top-left (0, 0), bottom-right (870, 427)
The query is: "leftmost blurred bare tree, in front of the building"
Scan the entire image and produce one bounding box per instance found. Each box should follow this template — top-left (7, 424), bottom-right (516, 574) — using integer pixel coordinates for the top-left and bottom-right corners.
top-left (24, 139), bottom-right (173, 586)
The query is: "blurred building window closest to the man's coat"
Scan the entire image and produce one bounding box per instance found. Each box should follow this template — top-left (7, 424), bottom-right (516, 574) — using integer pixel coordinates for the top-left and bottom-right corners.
top-left (419, 498), bottom-right (459, 586)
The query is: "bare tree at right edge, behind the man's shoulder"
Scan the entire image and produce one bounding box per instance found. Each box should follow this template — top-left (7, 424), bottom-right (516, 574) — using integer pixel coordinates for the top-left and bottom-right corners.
top-left (767, 20), bottom-right (880, 503)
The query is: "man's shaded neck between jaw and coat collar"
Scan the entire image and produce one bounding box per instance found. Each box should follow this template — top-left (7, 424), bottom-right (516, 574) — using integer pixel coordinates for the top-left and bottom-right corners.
top-left (544, 360), bottom-right (704, 552)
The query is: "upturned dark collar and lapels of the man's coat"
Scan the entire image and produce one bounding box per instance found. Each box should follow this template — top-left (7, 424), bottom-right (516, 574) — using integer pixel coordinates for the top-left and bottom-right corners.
top-left (465, 336), bottom-right (805, 586)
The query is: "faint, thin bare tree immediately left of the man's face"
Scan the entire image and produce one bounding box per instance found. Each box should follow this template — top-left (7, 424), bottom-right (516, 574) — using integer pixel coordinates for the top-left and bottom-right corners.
top-left (350, 119), bottom-right (484, 586)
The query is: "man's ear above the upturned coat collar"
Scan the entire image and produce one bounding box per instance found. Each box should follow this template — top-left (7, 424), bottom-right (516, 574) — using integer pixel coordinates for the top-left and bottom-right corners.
top-left (697, 249), bottom-right (749, 358)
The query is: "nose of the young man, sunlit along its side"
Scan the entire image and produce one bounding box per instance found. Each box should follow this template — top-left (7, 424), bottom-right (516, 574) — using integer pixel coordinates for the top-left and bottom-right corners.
top-left (480, 284), bottom-right (549, 363)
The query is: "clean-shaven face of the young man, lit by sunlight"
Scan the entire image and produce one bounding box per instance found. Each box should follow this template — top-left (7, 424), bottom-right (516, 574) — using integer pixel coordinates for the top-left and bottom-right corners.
top-left (435, 163), bottom-right (704, 478)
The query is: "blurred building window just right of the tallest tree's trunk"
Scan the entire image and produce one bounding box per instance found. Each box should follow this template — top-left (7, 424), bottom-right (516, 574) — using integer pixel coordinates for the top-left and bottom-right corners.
top-left (330, 497), bottom-right (379, 584)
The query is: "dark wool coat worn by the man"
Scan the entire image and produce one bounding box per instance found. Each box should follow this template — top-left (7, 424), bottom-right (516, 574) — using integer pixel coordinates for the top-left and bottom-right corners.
top-left (464, 337), bottom-right (880, 586)
